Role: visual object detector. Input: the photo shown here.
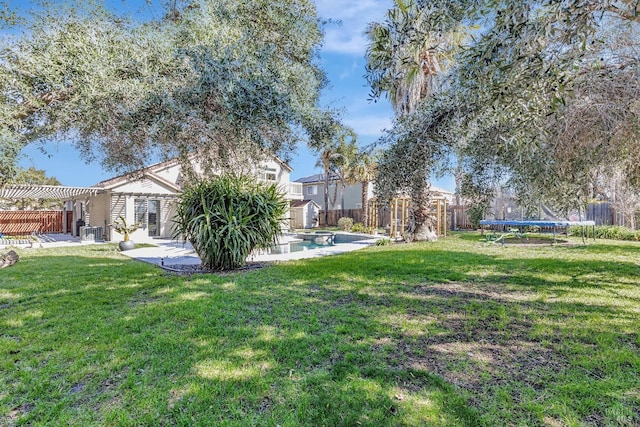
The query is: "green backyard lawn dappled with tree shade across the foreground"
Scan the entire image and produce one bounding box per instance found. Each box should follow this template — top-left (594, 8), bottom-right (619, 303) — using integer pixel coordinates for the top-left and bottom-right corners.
top-left (0, 234), bottom-right (640, 426)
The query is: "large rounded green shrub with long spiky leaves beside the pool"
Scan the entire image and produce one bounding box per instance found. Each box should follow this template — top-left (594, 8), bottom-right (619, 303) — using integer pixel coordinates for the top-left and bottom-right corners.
top-left (173, 175), bottom-right (287, 270)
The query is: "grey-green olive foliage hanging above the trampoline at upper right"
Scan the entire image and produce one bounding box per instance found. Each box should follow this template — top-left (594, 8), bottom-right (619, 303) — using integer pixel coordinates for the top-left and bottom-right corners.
top-left (368, 0), bottom-right (640, 219)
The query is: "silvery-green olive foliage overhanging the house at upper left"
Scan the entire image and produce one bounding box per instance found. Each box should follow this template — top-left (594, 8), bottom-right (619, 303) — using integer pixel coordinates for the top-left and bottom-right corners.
top-left (0, 0), bottom-right (325, 184)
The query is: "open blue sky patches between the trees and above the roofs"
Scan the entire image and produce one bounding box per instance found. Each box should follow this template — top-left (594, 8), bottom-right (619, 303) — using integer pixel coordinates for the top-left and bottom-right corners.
top-left (15, 0), bottom-right (454, 190)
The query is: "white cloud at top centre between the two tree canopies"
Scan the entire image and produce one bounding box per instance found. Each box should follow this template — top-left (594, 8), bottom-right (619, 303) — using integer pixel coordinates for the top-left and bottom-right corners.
top-left (316, 0), bottom-right (393, 55)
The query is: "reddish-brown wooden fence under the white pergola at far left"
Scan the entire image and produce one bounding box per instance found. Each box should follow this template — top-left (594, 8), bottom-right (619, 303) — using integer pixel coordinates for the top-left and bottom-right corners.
top-left (0, 211), bottom-right (65, 236)
